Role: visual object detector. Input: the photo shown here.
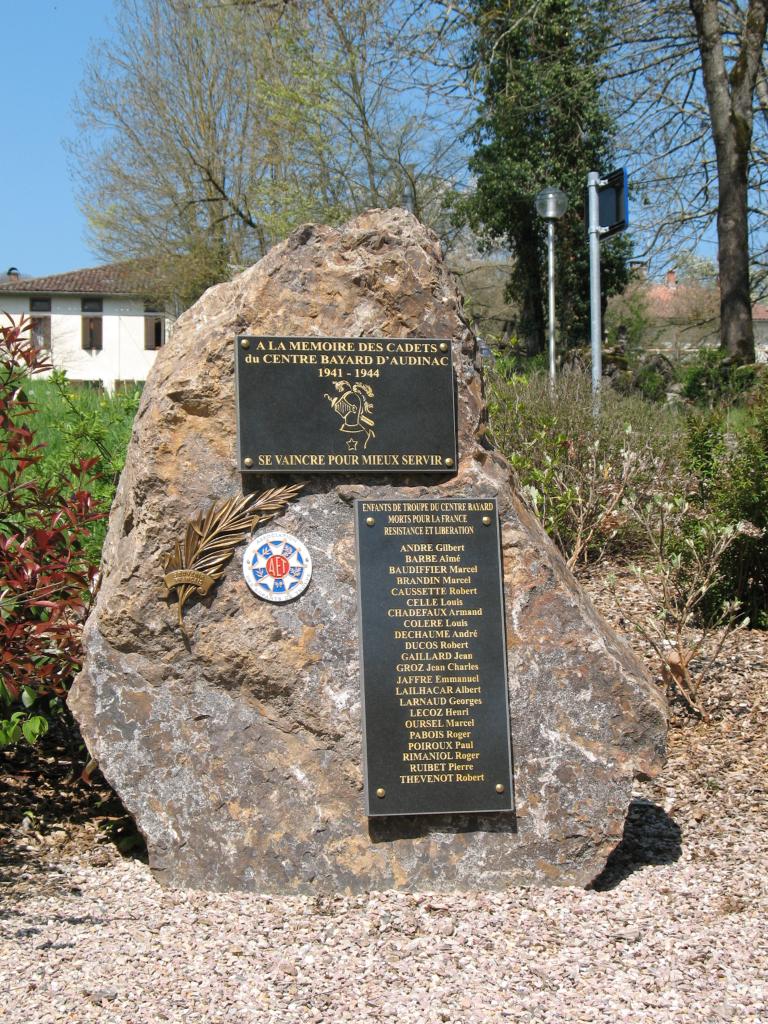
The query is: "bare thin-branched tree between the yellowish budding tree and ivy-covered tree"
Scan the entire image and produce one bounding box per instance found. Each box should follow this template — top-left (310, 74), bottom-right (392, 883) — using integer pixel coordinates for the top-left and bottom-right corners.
top-left (303, 0), bottom-right (465, 234)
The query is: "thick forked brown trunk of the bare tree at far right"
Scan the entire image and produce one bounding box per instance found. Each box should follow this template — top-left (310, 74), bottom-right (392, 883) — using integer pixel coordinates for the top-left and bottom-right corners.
top-left (690, 0), bottom-right (768, 362)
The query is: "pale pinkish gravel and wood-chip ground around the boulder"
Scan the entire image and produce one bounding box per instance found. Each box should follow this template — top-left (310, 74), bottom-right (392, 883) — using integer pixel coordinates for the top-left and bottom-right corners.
top-left (0, 578), bottom-right (768, 1024)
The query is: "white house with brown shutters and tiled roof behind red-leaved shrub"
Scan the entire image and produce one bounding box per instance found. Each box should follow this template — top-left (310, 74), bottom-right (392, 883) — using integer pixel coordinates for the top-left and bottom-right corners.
top-left (0, 263), bottom-right (170, 391)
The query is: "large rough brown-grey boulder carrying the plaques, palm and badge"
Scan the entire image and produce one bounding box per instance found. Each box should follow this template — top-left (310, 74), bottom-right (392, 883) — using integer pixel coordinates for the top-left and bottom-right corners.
top-left (71, 210), bottom-right (666, 893)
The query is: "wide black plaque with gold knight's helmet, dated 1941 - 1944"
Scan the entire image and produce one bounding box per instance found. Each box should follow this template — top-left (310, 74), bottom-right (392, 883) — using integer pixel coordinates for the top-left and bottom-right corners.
top-left (236, 336), bottom-right (457, 473)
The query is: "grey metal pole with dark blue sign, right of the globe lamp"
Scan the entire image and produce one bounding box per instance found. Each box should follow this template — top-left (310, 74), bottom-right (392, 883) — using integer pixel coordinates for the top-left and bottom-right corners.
top-left (587, 167), bottom-right (629, 412)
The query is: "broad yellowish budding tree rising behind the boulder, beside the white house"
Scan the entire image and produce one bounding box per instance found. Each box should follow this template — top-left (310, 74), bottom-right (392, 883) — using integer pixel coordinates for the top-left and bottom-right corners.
top-left (73, 0), bottom-right (322, 301)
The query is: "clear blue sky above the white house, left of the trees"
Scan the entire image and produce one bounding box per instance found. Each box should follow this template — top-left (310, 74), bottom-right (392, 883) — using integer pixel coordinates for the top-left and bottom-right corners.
top-left (0, 0), bottom-right (113, 275)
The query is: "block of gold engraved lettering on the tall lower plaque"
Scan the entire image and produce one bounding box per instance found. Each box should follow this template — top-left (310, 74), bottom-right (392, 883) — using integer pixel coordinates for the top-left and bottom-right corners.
top-left (359, 500), bottom-right (514, 813)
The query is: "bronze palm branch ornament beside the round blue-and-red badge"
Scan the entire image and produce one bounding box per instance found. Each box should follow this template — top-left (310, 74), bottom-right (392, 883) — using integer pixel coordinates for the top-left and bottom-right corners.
top-left (163, 483), bottom-right (304, 631)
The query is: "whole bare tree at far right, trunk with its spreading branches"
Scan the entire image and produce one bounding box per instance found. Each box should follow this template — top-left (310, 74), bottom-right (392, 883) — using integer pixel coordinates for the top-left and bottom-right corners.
top-left (606, 0), bottom-right (768, 360)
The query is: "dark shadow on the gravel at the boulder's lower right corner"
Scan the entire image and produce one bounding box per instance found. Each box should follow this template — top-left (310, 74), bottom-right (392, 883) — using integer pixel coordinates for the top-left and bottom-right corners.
top-left (588, 799), bottom-right (682, 892)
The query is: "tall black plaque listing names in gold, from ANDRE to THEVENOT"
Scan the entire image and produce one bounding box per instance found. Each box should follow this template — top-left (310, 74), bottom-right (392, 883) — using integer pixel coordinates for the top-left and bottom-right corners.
top-left (355, 499), bottom-right (513, 816)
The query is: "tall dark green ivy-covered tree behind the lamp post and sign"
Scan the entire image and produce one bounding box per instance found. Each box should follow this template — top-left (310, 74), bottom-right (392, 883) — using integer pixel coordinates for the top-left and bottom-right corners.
top-left (458, 0), bottom-right (627, 353)
